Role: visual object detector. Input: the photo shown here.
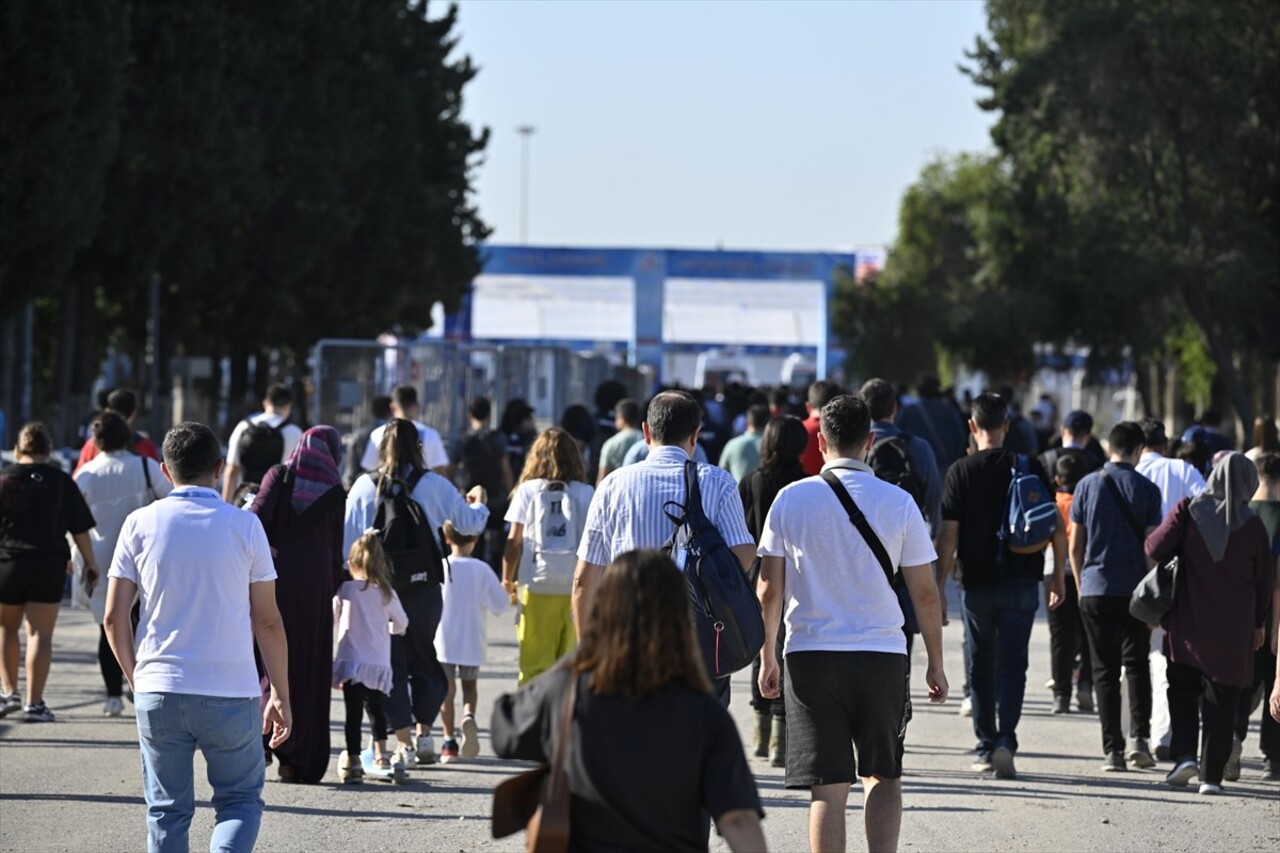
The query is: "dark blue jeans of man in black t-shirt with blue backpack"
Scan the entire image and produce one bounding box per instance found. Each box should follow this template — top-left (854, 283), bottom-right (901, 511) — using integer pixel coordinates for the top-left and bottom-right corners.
top-left (960, 578), bottom-right (1039, 752)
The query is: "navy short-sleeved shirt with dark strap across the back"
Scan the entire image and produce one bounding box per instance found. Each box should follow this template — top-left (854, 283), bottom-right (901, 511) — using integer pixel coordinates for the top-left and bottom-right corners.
top-left (1071, 462), bottom-right (1161, 598)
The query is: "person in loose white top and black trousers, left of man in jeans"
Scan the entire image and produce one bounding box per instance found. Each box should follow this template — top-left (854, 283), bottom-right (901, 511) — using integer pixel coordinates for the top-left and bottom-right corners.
top-left (73, 411), bottom-right (173, 717)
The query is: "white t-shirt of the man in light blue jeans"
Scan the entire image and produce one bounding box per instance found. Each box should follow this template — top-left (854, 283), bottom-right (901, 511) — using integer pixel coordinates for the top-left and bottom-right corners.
top-left (108, 485), bottom-right (275, 698)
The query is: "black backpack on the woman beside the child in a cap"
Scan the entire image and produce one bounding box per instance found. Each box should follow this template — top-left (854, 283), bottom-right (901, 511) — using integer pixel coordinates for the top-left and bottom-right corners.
top-left (374, 467), bottom-right (444, 592)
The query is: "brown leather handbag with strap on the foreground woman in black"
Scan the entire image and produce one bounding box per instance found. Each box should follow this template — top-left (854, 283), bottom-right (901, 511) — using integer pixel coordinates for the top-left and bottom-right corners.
top-left (492, 672), bottom-right (577, 853)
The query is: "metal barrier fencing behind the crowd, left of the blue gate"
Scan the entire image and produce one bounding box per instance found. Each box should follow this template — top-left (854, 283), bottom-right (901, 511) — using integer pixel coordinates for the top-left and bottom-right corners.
top-left (311, 338), bottom-right (644, 442)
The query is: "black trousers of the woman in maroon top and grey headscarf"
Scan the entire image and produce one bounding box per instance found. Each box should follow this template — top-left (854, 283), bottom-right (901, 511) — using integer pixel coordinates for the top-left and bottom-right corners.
top-left (1169, 661), bottom-right (1240, 785)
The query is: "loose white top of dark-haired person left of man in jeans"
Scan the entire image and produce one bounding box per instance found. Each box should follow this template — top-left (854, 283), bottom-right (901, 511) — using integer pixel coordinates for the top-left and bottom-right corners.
top-left (72, 450), bottom-right (173, 624)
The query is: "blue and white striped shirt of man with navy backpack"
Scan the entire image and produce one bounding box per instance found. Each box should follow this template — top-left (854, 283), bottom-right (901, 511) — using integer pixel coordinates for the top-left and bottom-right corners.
top-left (577, 444), bottom-right (755, 566)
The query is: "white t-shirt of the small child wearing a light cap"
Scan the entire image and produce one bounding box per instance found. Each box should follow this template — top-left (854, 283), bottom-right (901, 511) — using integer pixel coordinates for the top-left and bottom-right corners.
top-left (435, 557), bottom-right (511, 666)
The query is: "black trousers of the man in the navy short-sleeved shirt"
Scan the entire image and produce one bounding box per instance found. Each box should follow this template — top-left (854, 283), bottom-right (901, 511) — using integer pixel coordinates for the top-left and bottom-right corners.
top-left (1080, 596), bottom-right (1151, 754)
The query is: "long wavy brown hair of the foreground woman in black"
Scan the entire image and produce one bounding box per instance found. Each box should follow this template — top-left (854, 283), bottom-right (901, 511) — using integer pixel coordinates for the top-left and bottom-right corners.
top-left (573, 549), bottom-right (710, 699)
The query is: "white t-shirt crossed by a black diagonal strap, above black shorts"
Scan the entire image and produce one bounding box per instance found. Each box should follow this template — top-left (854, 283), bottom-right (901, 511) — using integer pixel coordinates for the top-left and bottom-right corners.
top-left (759, 460), bottom-right (937, 654)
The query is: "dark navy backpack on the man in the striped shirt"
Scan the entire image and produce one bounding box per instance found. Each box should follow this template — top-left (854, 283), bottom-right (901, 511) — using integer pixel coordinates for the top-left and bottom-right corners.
top-left (662, 460), bottom-right (764, 679)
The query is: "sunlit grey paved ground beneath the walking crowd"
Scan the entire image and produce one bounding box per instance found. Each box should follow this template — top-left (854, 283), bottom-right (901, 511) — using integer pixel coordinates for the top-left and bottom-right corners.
top-left (0, 591), bottom-right (1280, 853)
